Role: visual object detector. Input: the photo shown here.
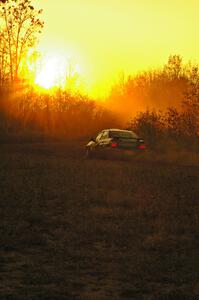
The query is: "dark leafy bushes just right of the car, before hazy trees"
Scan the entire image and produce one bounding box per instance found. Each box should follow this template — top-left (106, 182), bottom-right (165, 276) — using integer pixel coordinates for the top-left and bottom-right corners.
top-left (127, 107), bottom-right (199, 152)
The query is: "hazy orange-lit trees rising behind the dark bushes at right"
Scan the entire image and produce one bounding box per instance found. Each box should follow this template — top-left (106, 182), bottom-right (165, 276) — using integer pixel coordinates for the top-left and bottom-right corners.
top-left (108, 55), bottom-right (199, 119)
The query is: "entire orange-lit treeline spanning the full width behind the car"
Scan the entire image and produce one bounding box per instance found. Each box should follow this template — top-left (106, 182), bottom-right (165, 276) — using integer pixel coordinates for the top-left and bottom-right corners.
top-left (0, 55), bottom-right (199, 151)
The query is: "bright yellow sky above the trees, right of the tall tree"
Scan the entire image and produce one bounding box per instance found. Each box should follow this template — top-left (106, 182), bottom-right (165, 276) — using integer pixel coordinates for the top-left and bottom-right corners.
top-left (33, 0), bottom-right (199, 97)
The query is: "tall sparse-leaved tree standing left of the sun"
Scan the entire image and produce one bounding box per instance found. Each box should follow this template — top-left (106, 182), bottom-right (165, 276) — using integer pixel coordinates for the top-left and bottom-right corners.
top-left (0, 0), bottom-right (44, 82)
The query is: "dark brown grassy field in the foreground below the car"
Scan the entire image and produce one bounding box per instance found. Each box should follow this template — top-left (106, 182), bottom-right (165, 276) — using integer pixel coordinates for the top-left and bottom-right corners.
top-left (0, 142), bottom-right (199, 300)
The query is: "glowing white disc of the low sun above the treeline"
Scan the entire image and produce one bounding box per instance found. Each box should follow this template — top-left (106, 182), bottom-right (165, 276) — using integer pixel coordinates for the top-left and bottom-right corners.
top-left (35, 54), bottom-right (68, 90)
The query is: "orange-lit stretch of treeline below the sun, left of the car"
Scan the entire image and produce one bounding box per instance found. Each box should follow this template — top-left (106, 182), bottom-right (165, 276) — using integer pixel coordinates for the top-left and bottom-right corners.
top-left (0, 84), bottom-right (120, 140)
